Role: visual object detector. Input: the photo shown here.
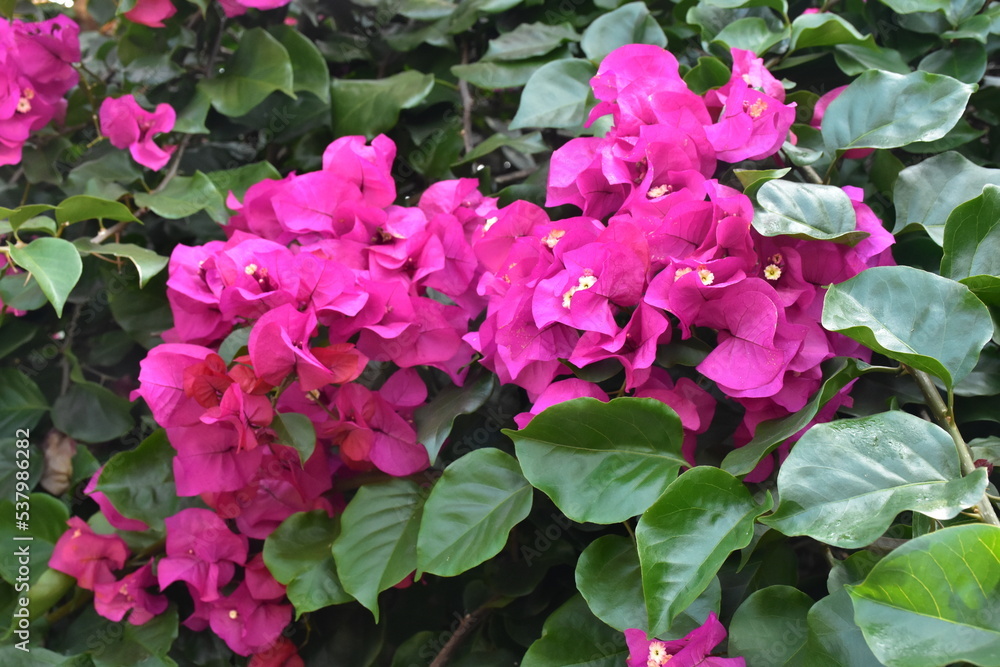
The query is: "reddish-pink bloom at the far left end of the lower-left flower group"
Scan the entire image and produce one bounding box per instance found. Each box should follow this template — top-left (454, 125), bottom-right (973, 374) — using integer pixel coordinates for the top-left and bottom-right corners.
top-left (49, 516), bottom-right (128, 591)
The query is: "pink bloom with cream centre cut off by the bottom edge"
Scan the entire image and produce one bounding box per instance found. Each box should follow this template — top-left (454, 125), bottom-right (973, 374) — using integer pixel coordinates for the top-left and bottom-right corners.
top-left (625, 612), bottom-right (746, 667)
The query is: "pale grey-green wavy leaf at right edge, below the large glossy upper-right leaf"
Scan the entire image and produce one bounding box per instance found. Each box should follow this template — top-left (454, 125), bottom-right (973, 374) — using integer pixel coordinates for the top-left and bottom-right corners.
top-left (892, 153), bottom-right (1000, 245)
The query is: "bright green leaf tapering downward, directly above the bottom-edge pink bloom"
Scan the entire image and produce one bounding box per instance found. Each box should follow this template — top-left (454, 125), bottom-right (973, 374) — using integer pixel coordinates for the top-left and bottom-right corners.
top-left (640, 468), bottom-right (773, 636)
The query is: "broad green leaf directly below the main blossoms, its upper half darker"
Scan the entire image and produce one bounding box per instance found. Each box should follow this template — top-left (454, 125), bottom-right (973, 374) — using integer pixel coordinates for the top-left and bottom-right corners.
top-left (504, 398), bottom-right (688, 524)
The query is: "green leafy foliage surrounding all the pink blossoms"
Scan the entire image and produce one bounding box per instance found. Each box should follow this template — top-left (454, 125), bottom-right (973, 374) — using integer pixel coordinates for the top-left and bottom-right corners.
top-left (0, 0), bottom-right (1000, 667)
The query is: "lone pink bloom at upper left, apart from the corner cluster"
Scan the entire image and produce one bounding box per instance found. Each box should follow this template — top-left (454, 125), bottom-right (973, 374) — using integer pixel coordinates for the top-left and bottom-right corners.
top-left (99, 95), bottom-right (177, 170)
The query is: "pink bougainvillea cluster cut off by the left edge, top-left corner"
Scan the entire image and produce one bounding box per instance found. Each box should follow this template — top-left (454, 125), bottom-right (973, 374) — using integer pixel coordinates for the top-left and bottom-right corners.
top-left (0, 16), bottom-right (80, 165)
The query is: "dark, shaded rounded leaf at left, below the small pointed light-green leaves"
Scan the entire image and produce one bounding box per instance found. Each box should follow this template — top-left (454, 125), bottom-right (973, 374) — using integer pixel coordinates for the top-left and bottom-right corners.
top-left (52, 382), bottom-right (135, 443)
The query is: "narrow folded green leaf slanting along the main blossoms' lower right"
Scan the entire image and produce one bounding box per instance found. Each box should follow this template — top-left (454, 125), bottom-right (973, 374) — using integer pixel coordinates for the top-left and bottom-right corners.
top-left (722, 357), bottom-right (885, 475)
